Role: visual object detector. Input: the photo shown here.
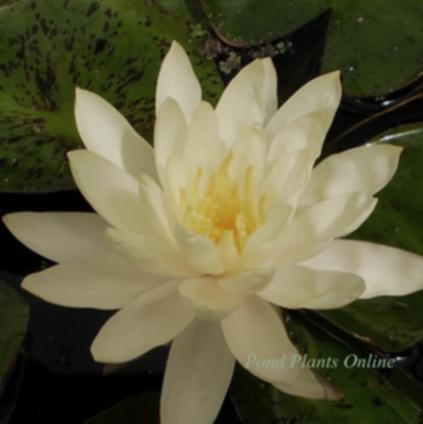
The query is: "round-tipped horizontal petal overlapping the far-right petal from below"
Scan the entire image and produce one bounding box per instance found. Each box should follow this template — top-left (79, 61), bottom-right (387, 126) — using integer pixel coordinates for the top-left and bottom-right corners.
top-left (258, 266), bottom-right (366, 309)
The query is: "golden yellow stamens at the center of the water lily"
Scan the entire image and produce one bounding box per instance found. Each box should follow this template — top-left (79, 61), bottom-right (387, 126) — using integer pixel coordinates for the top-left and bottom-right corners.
top-left (181, 153), bottom-right (257, 252)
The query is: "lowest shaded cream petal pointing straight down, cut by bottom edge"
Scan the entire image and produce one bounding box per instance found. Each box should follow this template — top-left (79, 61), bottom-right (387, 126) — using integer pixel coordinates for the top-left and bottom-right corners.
top-left (160, 320), bottom-right (235, 424)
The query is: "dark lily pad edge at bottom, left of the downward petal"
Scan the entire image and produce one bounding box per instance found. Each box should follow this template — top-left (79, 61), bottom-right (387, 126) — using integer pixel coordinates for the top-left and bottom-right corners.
top-left (86, 392), bottom-right (160, 424)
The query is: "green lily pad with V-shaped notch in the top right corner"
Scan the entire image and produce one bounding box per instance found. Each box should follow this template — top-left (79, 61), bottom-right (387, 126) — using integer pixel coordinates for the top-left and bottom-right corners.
top-left (202, 0), bottom-right (423, 97)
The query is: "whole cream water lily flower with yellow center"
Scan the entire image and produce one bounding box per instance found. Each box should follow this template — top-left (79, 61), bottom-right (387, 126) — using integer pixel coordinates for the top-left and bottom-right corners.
top-left (4, 42), bottom-right (423, 424)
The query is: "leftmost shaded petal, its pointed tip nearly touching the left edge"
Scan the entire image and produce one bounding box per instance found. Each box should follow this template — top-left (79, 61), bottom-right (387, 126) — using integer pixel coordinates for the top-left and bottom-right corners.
top-left (3, 212), bottom-right (110, 262)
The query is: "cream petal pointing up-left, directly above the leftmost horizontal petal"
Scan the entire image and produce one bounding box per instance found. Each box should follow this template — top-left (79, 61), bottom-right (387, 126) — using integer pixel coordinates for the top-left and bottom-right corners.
top-left (68, 150), bottom-right (145, 232)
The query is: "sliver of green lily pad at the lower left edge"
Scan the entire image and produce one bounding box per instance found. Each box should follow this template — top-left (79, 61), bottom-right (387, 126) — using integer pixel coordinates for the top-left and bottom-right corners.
top-left (0, 281), bottom-right (29, 395)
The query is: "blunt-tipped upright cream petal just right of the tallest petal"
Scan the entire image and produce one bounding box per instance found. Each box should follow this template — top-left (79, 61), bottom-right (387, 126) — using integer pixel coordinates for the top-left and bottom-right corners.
top-left (216, 58), bottom-right (277, 146)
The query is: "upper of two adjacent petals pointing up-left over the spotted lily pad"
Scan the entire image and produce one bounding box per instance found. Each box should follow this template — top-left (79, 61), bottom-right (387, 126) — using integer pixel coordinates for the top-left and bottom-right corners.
top-left (75, 88), bottom-right (157, 179)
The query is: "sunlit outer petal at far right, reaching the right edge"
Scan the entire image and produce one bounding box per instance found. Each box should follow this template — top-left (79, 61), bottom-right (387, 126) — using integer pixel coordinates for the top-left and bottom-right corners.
top-left (305, 240), bottom-right (423, 299)
